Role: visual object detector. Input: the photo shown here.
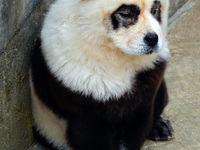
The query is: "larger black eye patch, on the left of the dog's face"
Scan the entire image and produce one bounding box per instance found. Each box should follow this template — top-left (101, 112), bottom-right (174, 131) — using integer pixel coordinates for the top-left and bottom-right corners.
top-left (111, 5), bottom-right (140, 29)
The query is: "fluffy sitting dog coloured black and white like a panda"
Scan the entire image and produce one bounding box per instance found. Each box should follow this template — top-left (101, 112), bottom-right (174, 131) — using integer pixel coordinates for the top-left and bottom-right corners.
top-left (30, 0), bottom-right (174, 150)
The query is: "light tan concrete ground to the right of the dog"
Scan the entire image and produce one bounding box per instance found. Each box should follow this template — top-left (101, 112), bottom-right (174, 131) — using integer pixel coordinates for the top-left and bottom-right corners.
top-left (142, 1), bottom-right (200, 150)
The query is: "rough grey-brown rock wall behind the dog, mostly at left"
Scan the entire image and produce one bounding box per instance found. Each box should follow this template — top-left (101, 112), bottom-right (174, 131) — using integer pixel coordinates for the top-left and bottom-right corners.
top-left (0, 0), bottom-right (193, 150)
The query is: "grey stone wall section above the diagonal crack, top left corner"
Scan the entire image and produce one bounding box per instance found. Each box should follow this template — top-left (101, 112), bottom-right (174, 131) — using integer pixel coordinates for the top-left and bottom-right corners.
top-left (0, 0), bottom-right (40, 51)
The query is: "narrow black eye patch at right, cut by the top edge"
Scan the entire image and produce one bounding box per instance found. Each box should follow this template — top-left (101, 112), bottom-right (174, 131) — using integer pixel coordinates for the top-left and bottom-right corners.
top-left (151, 0), bottom-right (162, 23)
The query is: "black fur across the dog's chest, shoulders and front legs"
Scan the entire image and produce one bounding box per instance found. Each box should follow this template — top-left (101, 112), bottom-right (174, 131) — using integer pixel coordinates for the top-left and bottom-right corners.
top-left (31, 41), bottom-right (173, 150)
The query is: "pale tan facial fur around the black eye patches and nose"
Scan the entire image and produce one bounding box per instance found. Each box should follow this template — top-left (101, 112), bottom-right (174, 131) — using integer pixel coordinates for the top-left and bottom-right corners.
top-left (103, 0), bottom-right (167, 55)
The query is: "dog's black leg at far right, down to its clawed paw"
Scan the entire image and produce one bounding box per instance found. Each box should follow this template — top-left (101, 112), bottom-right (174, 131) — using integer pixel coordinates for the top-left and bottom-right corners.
top-left (149, 80), bottom-right (174, 141)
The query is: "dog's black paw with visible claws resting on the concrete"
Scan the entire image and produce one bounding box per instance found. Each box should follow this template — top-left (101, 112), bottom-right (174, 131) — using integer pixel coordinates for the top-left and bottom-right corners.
top-left (149, 118), bottom-right (174, 141)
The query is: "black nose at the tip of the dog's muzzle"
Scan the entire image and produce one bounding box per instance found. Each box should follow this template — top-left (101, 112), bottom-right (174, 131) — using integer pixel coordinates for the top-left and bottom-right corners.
top-left (144, 33), bottom-right (158, 48)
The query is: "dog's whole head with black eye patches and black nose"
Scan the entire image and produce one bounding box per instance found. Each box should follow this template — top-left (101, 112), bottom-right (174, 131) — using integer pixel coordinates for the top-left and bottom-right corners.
top-left (78, 0), bottom-right (169, 55)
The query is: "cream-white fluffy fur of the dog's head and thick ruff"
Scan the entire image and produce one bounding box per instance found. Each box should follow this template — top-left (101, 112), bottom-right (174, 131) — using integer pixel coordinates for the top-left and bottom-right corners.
top-left (41, 0), bottom-right (169, 101)
